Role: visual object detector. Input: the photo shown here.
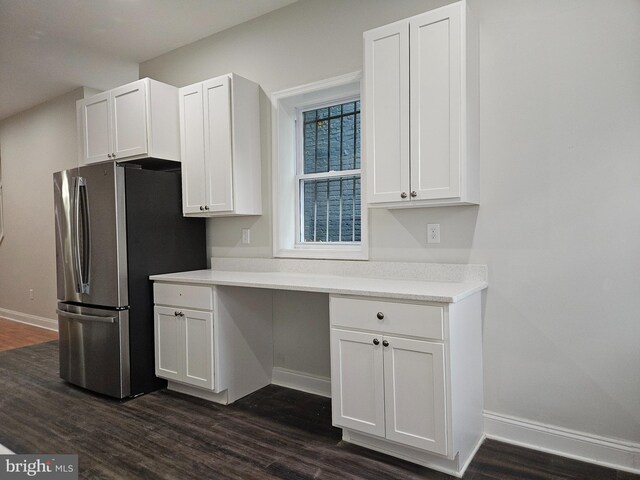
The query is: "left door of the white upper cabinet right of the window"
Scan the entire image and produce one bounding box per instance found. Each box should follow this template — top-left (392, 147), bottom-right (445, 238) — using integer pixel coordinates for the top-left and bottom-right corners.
top-left (363, 21), bottom-right (410, 203)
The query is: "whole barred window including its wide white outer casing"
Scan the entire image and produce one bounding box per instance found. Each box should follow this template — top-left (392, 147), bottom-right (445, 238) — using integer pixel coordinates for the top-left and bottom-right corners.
top-left (272, 73), bottom-right (368, 260)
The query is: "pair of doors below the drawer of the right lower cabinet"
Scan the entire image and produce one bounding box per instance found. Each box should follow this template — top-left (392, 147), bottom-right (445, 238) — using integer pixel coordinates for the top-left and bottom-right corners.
top-left (331, 316), bottom-right (447, 455)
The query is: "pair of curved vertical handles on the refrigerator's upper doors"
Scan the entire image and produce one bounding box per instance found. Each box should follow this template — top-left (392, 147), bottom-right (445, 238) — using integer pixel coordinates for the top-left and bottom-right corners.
top-left (72, 177), bottom-right (91, 293)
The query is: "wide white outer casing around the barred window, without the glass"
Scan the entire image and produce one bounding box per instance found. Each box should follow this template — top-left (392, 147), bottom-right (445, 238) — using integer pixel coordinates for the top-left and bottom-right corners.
top-left (271, 72), bottom-right (369, 260)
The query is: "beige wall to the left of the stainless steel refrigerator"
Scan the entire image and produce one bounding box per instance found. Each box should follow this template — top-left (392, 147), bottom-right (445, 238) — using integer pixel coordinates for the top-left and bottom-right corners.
top-left (0, 88), bottom-right (84, 328)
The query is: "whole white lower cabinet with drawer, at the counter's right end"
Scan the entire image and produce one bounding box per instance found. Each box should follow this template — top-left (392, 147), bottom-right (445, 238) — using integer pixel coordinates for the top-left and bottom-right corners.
top-left (330, 295), bottom-right (483, 476)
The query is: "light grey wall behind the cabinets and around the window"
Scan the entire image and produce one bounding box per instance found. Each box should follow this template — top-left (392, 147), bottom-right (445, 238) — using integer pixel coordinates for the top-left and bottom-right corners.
top-left (141, 0), bottom-right (640, 450)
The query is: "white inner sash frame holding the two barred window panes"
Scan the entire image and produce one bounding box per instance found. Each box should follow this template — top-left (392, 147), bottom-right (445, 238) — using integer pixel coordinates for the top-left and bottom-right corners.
top-left (295, 94), bottom-right (363, 249)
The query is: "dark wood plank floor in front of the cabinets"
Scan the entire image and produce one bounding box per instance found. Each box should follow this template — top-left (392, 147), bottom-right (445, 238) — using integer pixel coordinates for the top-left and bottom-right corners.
top-left (0, 341), bottom-right (640, 480)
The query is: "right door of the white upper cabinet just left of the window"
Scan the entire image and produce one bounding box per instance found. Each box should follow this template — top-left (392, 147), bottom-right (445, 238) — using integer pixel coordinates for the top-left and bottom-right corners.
top-left (202, 75), bottom-right (233, 212)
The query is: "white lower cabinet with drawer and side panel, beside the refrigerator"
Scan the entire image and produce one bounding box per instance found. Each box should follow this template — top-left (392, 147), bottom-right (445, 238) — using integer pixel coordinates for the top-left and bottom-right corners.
top-left (154, 282), bottom-right (273, 404)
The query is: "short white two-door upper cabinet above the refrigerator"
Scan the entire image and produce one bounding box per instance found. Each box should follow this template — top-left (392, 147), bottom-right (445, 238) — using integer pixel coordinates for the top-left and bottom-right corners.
top-left (77, 78), bottom-right (180, 165)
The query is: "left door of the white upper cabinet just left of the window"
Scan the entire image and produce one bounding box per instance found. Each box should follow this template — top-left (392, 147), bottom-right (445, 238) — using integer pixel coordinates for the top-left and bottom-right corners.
top-left (180, 84), bottom-right (207, 214)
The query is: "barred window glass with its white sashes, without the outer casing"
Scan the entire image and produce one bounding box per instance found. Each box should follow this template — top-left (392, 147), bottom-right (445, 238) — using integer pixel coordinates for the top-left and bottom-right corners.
top-left (296, 98), bottom-right (361, 244)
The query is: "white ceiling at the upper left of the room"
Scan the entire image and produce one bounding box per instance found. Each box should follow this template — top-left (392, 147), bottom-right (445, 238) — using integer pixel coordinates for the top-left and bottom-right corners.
top-left (0, 0), bottom-right (295, 120)
